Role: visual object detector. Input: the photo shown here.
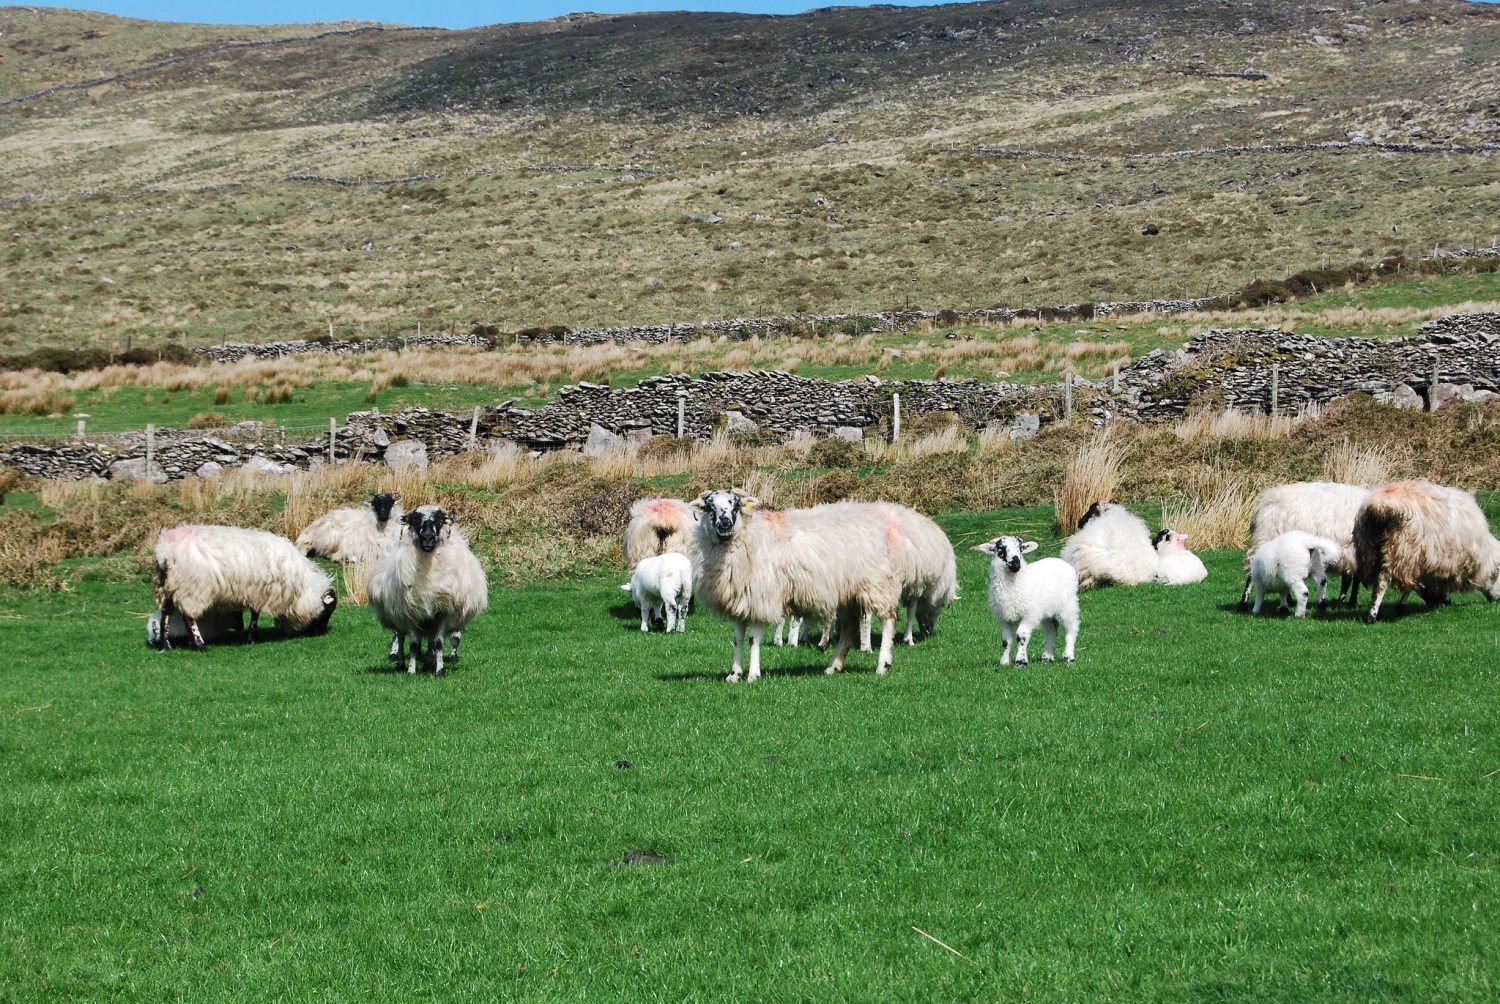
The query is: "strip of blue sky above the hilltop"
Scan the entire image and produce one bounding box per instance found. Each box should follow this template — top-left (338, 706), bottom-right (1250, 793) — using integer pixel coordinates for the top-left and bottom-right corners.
top-left (29, 0), bottom-right (960, 29)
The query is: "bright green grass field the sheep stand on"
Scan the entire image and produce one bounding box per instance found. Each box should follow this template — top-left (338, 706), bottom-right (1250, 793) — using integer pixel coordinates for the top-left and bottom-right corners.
top-left (0, 501), bottom-right (1500, 1001)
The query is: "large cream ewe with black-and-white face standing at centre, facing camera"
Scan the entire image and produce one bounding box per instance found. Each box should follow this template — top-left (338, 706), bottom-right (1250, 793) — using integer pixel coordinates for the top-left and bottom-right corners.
top-left (692, 489), bottom-right (902, 683)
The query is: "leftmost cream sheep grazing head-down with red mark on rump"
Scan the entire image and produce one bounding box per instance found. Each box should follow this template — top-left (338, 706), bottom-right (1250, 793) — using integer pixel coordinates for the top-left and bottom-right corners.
top-left (155, 524), bottom-right (338, 651)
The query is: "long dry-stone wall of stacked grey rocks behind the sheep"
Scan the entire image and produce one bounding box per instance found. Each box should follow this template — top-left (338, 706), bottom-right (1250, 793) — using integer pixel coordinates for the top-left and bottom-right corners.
top-left (0, 314), bottom-right (1500, 480)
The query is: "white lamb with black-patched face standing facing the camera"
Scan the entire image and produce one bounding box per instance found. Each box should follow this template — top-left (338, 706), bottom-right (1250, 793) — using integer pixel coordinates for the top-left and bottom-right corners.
top-left (974, 537), bottom-right (1079, 666)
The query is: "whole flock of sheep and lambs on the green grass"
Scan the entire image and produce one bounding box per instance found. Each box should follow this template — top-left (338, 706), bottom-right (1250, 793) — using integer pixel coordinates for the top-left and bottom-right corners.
top-left (147, 480), bottom-right (1500, 681)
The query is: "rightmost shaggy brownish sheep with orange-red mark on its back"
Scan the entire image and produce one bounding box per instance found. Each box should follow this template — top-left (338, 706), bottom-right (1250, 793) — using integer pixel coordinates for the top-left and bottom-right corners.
top-left (1355, 480), bottom-right (1500, 624)
